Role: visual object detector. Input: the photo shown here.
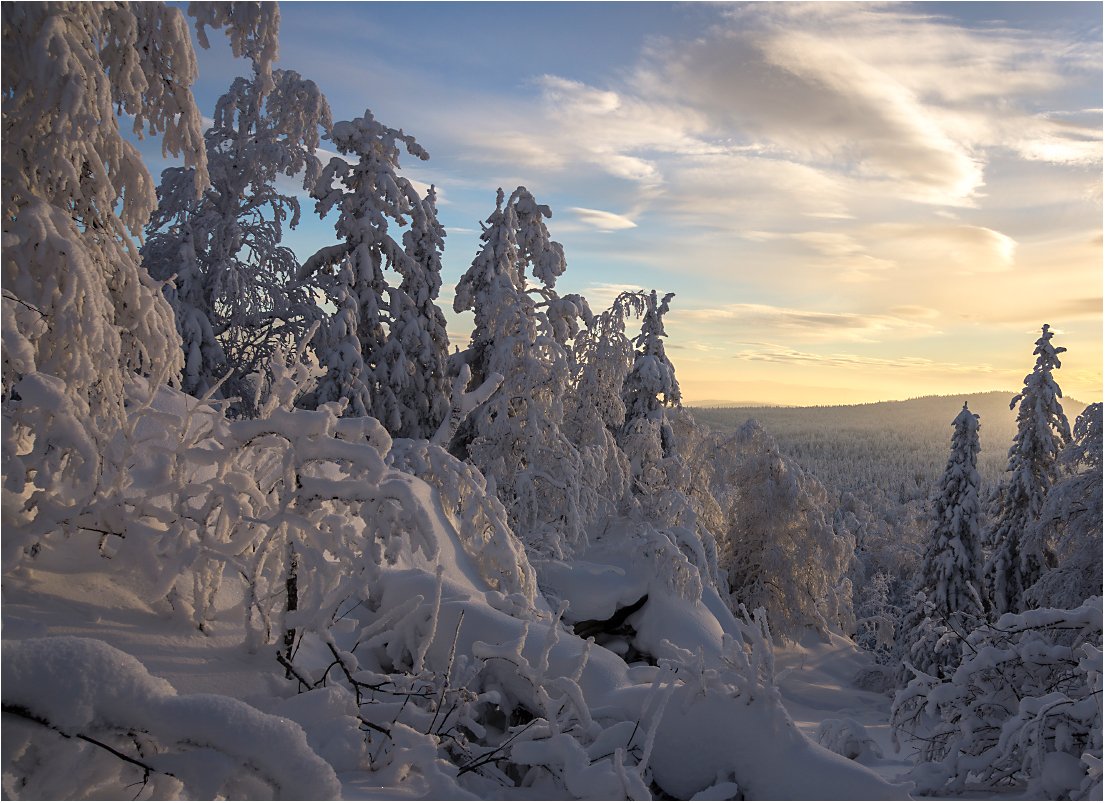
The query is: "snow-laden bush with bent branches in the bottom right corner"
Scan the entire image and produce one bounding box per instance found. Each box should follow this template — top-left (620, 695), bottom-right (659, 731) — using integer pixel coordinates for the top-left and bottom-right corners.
top-left (892, 596), bottom-right (1102, 800)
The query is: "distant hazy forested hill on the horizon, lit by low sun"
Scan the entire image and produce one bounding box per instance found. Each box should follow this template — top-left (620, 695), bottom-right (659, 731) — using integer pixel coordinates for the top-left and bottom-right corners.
top-left (692, 391), bottom-right (1086, 500)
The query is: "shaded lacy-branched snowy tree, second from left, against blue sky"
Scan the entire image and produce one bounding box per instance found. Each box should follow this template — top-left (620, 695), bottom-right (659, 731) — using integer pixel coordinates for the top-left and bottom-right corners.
top-left (143, 63), bottom-right (330, 413)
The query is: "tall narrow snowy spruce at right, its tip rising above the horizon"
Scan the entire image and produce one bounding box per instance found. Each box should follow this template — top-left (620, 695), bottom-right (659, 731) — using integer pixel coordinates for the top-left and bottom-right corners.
top-left (986, 324), bottom-right (1071, 615)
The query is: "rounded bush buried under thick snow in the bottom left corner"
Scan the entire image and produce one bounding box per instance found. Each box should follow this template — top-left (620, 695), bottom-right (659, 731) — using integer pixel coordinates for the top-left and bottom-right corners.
top-left (2, 636), bottom-right (341, 800)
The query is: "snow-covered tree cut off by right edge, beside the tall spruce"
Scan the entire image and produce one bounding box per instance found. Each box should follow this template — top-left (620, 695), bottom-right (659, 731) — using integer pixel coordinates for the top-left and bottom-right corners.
top-left (1024, 402), bottom-right (1102, 607)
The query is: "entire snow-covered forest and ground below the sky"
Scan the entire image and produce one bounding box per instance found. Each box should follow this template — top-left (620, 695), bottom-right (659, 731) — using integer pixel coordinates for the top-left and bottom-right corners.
top-left (0, 2), bottom-right (1103, 800)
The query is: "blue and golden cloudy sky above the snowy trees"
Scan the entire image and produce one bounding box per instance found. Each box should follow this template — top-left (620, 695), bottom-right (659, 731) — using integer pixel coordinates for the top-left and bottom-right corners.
top-left (160, 2), bottom-right (1103, 404)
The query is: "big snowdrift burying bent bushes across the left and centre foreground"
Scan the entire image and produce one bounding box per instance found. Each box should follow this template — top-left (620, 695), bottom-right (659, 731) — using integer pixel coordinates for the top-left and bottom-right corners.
top-left (2, 387), bottom-right (905, 800)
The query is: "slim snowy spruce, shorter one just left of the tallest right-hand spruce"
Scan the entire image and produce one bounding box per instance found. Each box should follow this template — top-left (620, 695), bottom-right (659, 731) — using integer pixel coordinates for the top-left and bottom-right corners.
top-left (899, 402), bottom-right (983, 682)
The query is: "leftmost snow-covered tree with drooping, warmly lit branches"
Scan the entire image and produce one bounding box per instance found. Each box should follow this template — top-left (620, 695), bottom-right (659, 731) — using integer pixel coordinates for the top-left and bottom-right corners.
top-left (0, 2), bottom-right (275, 549)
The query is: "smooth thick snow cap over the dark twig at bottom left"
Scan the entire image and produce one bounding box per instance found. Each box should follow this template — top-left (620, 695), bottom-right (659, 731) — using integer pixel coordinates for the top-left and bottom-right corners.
top-left (2, 636), bottom-right (341, 800)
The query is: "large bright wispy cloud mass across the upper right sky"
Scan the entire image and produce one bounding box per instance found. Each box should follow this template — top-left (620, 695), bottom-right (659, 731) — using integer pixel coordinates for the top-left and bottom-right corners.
top-left (439, 3), bottom-right (1101, 224)
